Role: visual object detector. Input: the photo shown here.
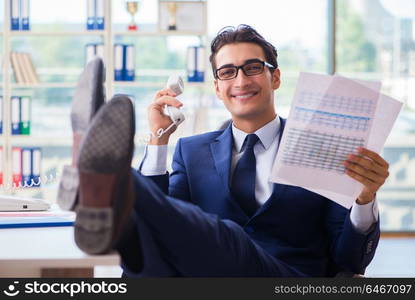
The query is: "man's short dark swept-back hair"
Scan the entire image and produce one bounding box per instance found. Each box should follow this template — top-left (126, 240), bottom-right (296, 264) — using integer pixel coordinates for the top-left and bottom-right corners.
top-left (209, 24), bottom-right (278, 77)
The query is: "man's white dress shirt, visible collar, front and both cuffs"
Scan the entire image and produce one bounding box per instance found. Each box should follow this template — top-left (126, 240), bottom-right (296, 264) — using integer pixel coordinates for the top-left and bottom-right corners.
top-left (140, 117), bottom-right (378, 233)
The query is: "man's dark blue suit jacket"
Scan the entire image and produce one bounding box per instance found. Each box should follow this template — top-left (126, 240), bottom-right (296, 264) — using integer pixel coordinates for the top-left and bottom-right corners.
top-left (145, 119), bottom-right (380, 276)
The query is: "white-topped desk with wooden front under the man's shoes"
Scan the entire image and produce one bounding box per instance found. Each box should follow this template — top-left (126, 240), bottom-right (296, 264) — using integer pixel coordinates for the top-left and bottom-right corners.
top-left (0, 226), bottom-right (120, 277)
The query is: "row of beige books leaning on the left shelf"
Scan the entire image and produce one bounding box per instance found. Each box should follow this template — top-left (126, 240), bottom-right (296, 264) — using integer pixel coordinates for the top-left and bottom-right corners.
top-left (10, 51), bottom-right (39, 84)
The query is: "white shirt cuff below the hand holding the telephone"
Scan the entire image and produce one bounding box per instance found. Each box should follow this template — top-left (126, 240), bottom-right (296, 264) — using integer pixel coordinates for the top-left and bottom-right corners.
top-left (140, 145), bottom-right (167, 176)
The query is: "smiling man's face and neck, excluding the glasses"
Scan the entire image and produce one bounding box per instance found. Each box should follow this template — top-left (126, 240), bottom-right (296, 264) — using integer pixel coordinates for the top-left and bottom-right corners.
top-left (215, 43), bottom-right (280, 122)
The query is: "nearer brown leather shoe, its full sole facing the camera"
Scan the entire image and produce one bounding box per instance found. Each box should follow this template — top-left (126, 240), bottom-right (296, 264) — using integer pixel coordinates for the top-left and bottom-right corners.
top-left (75, 96), bottom-right (135, 254)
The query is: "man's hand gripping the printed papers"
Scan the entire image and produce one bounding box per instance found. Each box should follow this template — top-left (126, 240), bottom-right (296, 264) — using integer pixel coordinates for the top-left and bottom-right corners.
top-left (343, 148), bottom-right (389, 204)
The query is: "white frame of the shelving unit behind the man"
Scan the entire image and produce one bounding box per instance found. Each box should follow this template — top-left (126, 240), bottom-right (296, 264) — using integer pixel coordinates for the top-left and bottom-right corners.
top-left (0, 0), bottom-right (208, 199)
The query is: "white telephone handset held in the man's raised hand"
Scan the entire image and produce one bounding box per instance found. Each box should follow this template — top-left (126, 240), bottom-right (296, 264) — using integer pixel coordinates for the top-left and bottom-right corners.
top-left (151, 75), bottom-right (185, 138)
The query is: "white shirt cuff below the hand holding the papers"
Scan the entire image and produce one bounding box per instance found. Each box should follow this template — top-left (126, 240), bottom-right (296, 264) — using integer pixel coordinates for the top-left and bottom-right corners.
top-left (350, 198), bottom-right (379, 233)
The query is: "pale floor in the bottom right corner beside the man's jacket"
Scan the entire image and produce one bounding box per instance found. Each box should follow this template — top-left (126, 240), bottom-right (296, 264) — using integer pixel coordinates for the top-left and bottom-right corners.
top-left (365, 238), bottom-right (415, 277)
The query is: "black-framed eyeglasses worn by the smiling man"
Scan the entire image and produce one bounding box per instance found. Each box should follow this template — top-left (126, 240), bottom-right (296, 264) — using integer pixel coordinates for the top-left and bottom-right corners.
top-left (215, 59), bottom-right (276, 80)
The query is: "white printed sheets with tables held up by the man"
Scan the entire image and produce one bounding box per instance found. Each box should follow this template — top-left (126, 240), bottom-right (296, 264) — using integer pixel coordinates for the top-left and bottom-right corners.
top-left (270, 73), bottom-right (402, 208)
